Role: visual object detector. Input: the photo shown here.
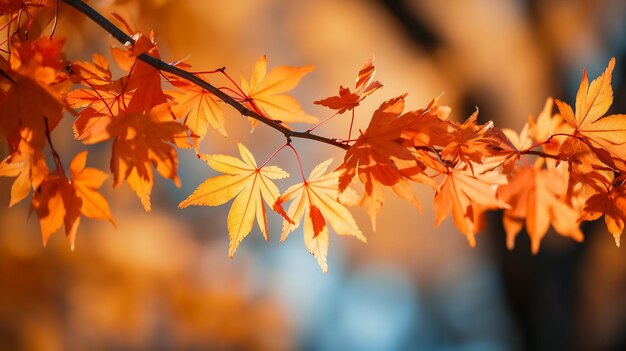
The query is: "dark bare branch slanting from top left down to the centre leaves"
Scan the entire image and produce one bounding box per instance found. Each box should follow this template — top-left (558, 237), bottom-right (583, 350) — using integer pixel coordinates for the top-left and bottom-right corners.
top-left (61, 0), bottom-right (350, 150)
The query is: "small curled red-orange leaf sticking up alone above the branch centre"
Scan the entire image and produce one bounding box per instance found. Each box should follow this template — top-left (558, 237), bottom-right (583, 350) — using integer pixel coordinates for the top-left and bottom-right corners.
top-left (313, 57), bottom-right (383, 114)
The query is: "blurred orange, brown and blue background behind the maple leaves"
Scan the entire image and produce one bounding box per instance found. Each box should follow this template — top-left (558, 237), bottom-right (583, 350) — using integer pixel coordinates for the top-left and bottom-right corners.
top-left (0, 0), bottom-right (626, 350)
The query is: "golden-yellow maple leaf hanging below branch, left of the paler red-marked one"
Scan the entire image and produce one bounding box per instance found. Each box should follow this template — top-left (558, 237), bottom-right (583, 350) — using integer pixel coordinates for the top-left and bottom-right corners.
top-left (178, 143), bottom-right (289, 257)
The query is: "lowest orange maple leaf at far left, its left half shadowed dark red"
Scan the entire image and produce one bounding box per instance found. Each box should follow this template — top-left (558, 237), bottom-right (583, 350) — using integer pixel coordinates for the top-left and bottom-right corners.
top-left (31, 151), bottom-right (115, 250)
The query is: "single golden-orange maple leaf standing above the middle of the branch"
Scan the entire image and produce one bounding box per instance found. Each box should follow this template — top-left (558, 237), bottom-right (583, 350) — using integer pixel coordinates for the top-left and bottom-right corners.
top-left (241, 56), bottom-right (318, 127)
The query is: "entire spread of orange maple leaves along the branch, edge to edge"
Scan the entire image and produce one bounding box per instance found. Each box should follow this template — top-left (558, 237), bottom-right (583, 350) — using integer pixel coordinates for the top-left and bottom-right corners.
top-left (0, 1), bottom-right (626, 271)
